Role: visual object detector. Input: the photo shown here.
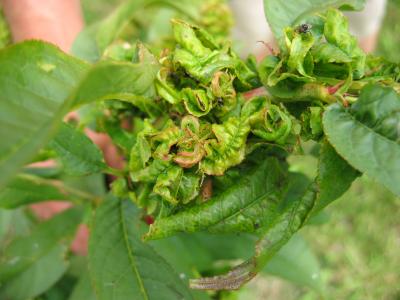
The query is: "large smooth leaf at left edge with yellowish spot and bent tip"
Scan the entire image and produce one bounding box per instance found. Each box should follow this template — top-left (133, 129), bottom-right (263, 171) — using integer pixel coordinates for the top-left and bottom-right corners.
top-left (0, 41), bottom-right (158, 185)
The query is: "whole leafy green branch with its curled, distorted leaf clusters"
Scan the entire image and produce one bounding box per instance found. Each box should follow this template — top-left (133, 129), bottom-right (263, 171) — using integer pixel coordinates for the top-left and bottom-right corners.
top-left (0, 0), bottom-right (400, 300)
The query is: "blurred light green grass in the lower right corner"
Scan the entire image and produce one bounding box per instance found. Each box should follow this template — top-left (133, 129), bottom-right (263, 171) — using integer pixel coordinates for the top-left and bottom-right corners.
top-left (304, 177), bottom-right (400, 300)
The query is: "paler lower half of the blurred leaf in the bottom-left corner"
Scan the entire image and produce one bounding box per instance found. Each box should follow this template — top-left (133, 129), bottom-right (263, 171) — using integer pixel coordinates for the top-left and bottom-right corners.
top-left (0, 245), bottom-right (69, 300)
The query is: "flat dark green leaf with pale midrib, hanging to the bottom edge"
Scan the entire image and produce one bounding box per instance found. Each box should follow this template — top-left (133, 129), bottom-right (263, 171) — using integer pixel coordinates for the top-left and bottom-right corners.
top-left (89, 198), bottom-right (192, 300)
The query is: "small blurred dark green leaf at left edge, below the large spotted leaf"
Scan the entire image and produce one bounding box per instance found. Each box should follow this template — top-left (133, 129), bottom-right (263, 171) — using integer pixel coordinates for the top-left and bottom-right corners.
top-left (0, 176), bottom-right (68, 209)
